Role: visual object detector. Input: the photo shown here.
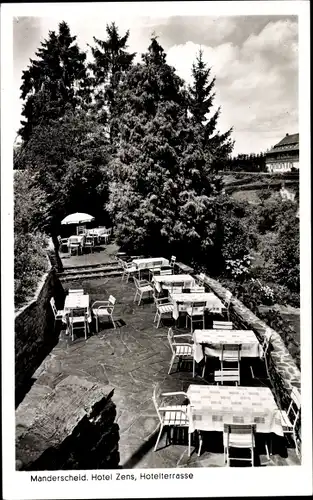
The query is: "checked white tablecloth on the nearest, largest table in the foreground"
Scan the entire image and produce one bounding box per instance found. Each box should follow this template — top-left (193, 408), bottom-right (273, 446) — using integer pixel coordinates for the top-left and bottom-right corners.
top-left (187, 384), bottom-right (283, 436)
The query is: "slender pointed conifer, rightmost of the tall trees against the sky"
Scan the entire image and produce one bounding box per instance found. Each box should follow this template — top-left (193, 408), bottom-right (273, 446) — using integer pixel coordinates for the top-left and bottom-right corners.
top-left (188, 49), bottom-right (233, 168)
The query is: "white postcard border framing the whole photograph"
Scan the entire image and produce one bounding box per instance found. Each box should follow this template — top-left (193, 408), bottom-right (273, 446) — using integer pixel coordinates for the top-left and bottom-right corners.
top-left (1, 1), bottom-right (312, 500)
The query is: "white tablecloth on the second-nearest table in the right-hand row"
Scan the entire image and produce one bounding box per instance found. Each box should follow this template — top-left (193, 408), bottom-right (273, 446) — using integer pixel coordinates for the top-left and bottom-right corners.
top-left (193, 330), bottom-right (260, 363)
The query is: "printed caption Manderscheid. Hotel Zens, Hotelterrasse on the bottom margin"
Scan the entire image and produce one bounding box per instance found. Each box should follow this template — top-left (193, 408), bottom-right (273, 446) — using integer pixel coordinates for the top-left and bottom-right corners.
top-left (30, 472), bottom-right (193, 483)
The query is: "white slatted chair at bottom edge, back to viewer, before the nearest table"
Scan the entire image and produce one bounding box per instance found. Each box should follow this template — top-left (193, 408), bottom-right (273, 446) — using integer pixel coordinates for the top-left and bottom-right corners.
top-left (223, 424), bottom-right (256, 467)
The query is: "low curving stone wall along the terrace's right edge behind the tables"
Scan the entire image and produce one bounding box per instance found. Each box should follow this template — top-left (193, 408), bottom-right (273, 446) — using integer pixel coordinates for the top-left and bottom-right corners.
top-left (195, 276), bottom-right (301, 450)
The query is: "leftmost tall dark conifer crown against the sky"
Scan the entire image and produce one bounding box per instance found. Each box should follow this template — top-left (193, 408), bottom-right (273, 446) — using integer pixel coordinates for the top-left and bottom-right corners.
top-left (19, 21), bottom-right (90, 142)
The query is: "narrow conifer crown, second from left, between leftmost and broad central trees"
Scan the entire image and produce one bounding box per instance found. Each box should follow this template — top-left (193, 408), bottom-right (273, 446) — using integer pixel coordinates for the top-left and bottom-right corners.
top-left (89, 22), bottom-right (136, 141)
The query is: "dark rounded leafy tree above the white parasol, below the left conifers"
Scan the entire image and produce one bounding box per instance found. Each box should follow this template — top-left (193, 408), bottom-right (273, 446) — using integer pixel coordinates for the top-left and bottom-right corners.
top-left (16, 111), bottom-right (108, 236)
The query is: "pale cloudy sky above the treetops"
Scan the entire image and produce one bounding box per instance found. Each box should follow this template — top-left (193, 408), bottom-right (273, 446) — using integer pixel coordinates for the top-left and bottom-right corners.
top-left (13, 13), bottom-right (299, 154)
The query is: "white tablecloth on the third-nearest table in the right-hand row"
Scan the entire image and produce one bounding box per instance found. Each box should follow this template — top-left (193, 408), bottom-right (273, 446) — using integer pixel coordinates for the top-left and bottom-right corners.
top-left (169, 292), bottom-right (224, 319)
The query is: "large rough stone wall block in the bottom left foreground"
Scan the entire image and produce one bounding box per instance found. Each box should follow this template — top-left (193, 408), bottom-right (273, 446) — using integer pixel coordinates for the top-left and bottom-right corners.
top-left (16, 375), bottom-right (119, 471)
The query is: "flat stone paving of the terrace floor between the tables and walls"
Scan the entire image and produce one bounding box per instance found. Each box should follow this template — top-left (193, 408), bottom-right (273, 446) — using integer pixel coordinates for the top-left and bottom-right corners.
top-left (30, 270), bottom-right (299, 468)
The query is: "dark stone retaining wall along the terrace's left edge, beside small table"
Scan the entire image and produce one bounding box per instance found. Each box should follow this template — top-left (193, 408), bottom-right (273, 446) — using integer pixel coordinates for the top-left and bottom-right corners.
top-left (15, 268), bottom-right (64, 406)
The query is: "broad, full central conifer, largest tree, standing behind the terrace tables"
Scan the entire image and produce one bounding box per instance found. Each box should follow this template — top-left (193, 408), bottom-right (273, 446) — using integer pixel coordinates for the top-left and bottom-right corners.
top-left (108, 37), bottom-right (225, 268)
